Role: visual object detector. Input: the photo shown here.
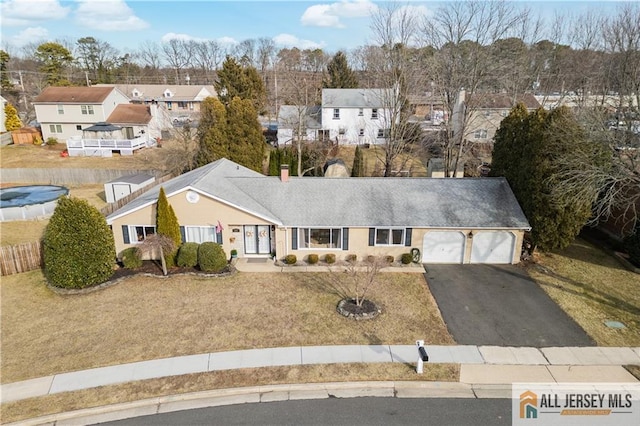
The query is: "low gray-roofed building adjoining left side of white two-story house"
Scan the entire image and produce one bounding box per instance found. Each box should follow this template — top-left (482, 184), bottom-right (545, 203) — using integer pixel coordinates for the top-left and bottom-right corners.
top-left (278, 105), bottom-right (323, 146)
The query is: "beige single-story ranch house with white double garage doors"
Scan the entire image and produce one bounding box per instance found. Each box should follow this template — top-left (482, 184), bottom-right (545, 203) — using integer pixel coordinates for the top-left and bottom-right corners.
top-left (107, 159), bottom-right (530, 263)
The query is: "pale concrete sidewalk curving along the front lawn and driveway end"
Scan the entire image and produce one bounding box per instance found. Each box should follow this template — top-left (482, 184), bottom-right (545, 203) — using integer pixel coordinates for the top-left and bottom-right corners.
top-left (0, 345), bottom-right (640, 403)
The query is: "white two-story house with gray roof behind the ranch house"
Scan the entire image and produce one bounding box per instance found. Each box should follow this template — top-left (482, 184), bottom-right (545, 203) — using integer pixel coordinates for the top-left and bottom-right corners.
top-left (321, 89), bottom-right (395, 144)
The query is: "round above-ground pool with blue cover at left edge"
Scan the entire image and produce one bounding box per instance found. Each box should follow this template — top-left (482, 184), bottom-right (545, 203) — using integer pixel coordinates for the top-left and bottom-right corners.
top-left (0, 185), bottom-right (69, 221)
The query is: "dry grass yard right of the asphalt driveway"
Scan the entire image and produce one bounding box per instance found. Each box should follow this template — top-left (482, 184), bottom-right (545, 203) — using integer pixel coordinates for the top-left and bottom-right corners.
top-left (528, 239), bottom-right (640, 346)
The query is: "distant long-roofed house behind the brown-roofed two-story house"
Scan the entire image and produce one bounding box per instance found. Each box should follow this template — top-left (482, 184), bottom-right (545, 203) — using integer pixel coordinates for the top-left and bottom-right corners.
top-left (96, 84), bottom-right (217, 117)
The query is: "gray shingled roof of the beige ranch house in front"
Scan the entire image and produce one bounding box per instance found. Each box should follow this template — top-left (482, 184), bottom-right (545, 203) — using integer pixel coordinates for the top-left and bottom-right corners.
top-left (107, 159), bottom-right (530, 229)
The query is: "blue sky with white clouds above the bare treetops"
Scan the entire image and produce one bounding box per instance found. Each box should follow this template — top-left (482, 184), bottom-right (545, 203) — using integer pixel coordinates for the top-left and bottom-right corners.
top-left (0, 0), bottom-right (632, 53)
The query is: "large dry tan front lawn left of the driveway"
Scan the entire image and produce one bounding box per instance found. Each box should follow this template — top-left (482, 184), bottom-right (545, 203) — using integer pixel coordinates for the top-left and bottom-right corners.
top-left (0, 271), bottom-right (453, 383)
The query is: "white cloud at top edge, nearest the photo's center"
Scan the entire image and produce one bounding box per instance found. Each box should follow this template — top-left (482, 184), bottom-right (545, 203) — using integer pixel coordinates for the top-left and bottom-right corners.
top-left (300, 0), bottom-right (378, 28)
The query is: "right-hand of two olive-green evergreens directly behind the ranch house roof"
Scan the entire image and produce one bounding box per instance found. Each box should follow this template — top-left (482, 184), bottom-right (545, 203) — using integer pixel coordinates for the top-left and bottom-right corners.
top-left (227, 97), bottom-right (265, 172)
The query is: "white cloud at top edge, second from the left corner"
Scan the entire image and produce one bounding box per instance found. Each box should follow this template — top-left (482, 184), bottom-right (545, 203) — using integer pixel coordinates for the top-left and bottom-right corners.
top-left (75, 0), bottom-right (149, 31)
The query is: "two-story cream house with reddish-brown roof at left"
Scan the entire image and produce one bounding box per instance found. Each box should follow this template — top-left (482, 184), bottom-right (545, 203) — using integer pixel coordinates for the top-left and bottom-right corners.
top-left (33, 86), bottom-right (129, 142)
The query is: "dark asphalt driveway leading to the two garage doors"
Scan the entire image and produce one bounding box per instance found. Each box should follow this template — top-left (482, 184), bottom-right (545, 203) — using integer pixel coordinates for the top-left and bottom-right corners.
top-left (425, 265), bottom-right (595, 347)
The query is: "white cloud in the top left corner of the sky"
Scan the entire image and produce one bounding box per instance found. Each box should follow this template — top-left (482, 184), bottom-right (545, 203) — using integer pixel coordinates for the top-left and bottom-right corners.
top-left (0, 0), bottom-right (70, 27)
